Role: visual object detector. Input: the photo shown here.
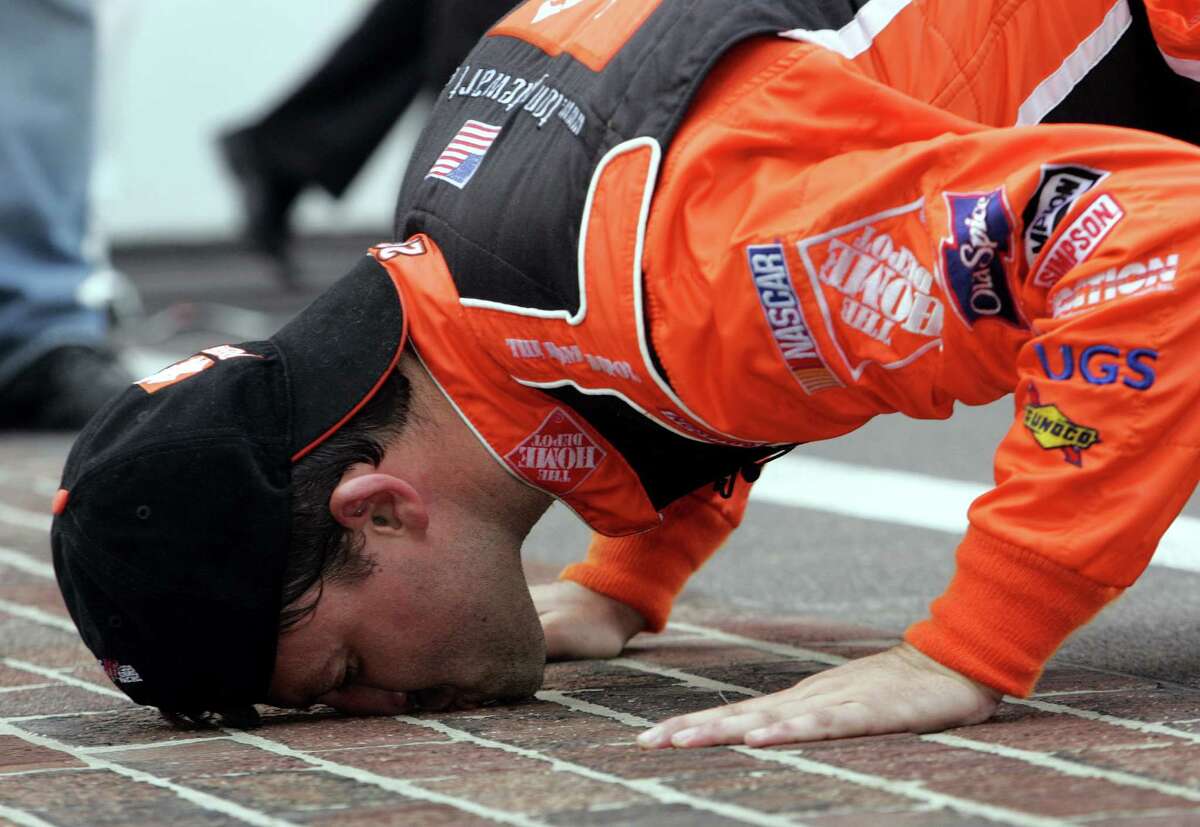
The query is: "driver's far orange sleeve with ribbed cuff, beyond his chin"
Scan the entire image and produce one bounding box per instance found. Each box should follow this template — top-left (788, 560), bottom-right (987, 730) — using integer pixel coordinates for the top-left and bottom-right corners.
top-left (562, 478), bottom-right (750, 631)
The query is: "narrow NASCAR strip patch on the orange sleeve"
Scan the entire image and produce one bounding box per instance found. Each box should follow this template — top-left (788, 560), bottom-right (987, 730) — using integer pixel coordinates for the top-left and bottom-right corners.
top-left (746, 244), bottom-right (842, 396)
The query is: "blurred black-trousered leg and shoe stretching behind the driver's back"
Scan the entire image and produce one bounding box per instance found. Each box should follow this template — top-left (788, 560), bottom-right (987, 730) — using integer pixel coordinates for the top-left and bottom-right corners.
top-left (221, 0), bottom-right (516, 283)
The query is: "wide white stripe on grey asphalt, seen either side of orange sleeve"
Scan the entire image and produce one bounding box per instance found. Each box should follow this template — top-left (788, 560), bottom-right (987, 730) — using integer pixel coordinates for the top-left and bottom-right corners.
top-left (750, 455), bottom-right (1200, 571)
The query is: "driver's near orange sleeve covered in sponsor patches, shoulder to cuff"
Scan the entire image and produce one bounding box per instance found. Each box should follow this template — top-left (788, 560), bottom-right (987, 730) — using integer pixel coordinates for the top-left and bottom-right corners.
top-left (646, 42), bottom-right (1200, 695)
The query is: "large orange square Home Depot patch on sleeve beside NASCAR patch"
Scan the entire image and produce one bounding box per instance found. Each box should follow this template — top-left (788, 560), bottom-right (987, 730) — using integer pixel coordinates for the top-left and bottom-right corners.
top-left (796, 199), bottom-right (946, 380)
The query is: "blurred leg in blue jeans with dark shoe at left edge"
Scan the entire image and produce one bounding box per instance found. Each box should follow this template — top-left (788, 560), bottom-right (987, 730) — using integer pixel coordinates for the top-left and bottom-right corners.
top-left (0, 0), bottom-right (128, 430)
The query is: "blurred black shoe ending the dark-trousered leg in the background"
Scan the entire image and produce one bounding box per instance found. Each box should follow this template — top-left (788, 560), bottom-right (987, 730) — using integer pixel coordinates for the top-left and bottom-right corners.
top-left (220, 131), bottom-right (304, 282)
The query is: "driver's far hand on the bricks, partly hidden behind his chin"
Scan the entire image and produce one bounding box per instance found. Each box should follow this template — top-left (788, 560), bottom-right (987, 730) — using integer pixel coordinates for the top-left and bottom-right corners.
top-left (529, 580), bottom-right (646, 660)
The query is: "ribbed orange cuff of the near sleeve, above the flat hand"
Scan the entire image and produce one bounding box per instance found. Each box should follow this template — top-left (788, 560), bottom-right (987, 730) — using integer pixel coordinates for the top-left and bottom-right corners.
top-left (905, 527), bottom-right (1122, 697)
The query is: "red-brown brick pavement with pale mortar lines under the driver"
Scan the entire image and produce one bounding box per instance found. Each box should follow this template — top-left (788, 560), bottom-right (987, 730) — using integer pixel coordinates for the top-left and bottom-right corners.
top-left (0, 437), bottom-right (1200, 827)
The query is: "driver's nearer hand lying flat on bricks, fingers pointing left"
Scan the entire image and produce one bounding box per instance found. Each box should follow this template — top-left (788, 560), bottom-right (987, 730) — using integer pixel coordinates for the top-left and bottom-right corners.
top-left (637, 643), bottom-right (1001, 749)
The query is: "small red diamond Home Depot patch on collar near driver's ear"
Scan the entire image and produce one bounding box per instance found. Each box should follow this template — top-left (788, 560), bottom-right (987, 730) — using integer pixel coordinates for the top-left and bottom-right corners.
top-left (504, 408), bottom-right (607, 497)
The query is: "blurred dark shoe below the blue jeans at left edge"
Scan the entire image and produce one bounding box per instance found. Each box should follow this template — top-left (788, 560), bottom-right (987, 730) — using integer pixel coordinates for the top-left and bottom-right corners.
top-left (0, 346), bottom-right (132, 431)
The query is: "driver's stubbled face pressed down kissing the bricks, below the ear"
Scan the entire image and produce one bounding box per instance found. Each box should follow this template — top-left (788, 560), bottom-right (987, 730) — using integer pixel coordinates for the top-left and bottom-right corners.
top-left (271, 532), bottom-right (545, 714)
